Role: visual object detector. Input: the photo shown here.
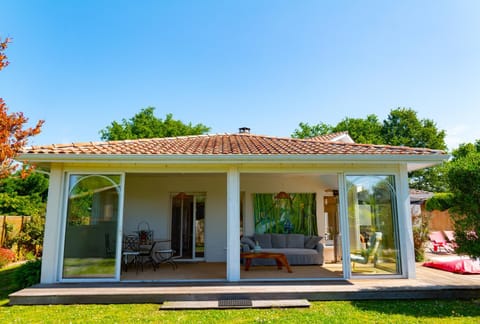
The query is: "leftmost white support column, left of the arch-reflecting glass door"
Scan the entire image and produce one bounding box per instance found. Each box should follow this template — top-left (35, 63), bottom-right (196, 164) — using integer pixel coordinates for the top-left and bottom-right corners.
top-left (40, 166), bottom-right (64, 283)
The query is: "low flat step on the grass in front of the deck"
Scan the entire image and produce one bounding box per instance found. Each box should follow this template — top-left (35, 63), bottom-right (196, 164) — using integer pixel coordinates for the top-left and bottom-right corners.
top-left (160, 298), bottom-right (310, 310)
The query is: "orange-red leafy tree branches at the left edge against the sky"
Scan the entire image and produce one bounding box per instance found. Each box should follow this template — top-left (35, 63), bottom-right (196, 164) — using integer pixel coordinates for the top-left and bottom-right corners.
top-left (0, 38), bottom-right (43, 178)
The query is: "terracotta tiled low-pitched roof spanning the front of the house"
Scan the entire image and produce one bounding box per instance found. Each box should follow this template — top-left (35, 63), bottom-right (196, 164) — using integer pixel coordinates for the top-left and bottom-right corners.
top-left (22, 134), bottom-right (445, 155)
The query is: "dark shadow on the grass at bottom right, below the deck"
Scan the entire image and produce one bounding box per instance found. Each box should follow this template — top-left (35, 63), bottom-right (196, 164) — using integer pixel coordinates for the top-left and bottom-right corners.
top-left (352, 299), bottom-right (480, 318)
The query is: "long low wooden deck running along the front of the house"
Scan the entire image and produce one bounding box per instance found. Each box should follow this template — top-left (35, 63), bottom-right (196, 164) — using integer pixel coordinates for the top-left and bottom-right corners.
top-left (10, 264), bottom-right (480, 305)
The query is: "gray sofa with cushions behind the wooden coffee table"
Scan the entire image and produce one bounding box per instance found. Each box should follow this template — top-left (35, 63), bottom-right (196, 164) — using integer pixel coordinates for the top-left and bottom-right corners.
top-left (240, 234), bottom-right (323, 265)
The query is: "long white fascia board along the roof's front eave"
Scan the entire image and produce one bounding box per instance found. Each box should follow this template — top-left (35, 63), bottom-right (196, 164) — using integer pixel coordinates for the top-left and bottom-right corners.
top-left (19, 154), bottom-right (449, 171)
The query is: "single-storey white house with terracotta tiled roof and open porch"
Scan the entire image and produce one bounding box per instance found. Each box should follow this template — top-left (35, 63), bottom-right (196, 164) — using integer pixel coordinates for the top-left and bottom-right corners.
top-left (19, 128), bottom-right (448, 283)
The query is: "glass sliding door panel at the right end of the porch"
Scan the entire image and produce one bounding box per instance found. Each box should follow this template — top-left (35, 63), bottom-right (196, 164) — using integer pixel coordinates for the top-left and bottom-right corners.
top-left (346, 175), bottom-right (401, 275)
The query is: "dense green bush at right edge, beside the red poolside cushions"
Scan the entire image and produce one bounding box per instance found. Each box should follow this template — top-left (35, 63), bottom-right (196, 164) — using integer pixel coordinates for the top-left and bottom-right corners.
top-left (448, 152), bottom-right (480, 258)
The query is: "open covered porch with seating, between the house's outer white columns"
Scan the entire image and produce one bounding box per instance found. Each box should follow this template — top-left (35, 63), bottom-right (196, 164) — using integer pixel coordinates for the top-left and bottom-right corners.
top-left (53, 167), bottom-right (412, 283)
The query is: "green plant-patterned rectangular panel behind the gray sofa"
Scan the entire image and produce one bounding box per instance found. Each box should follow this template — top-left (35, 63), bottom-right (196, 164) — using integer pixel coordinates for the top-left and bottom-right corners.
top-left (253, 193), bottom-right (318, 235)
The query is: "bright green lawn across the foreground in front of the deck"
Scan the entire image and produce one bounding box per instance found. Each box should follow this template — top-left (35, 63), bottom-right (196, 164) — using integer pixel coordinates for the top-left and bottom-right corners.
top-left (0, 266), bottom-right (480, 324)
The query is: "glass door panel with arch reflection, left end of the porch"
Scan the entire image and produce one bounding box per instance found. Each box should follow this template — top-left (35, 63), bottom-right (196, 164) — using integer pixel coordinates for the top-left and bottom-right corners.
top-left (62, 174), bottom-right (121, 279)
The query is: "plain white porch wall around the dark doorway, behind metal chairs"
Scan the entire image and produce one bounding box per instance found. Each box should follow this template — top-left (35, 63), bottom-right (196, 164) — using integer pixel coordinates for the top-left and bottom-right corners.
top-left (123, 173), bottom-right (227, 262)
